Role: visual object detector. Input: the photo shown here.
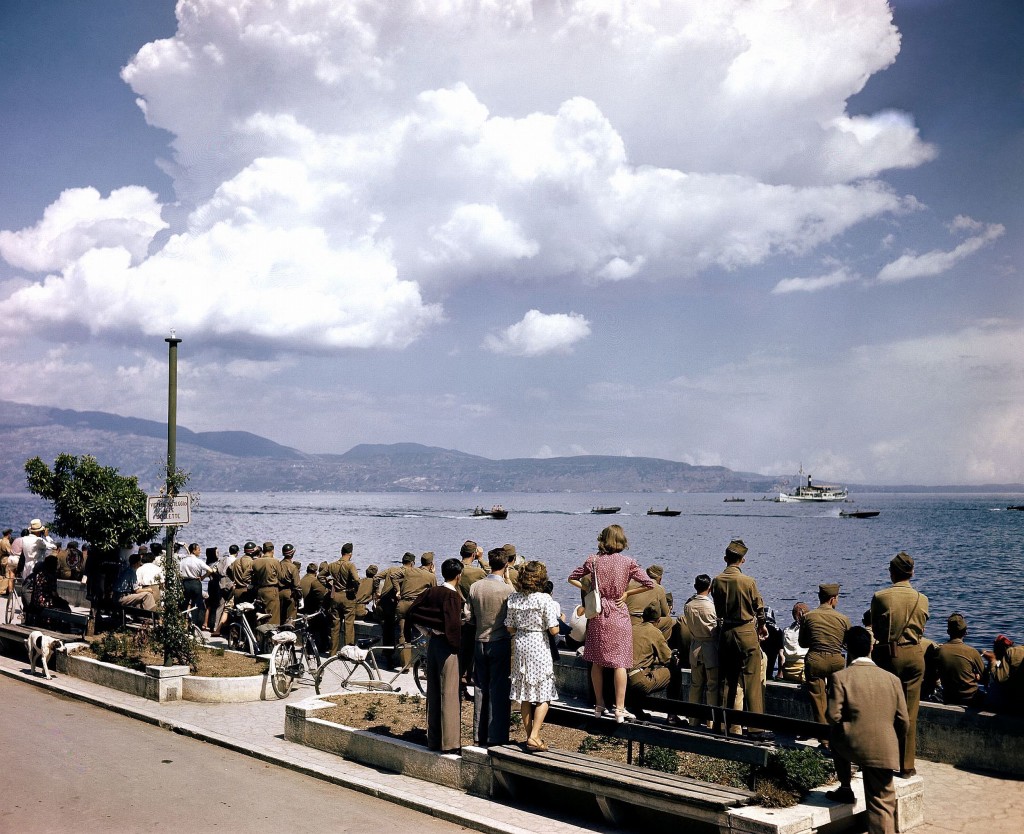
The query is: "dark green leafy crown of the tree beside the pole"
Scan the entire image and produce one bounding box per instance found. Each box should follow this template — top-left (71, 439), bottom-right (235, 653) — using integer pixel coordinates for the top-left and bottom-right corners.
top-left (25, 454), bottom-right (153, 552)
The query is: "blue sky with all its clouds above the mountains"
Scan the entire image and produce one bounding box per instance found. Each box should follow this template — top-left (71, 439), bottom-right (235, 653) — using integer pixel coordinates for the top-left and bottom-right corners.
top-left (0, 0), bottom-right (1024, 488)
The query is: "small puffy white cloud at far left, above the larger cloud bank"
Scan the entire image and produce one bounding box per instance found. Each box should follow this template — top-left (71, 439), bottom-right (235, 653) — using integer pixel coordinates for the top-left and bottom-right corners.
top-left (0, 185), bottom-right (167, 273)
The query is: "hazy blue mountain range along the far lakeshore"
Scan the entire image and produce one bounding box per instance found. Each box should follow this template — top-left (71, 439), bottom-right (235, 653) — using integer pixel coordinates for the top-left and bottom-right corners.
top-left (0, 400), bottom-right (1022, 493)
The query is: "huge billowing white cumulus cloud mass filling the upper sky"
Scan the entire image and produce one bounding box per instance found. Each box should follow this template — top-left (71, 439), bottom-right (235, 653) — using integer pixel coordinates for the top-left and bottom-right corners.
top-left (0, 0), bottom-right (934, 349)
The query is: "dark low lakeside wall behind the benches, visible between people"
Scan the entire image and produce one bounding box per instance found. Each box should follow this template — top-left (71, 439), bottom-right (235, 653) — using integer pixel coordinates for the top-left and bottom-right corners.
top-left (555, 652), bottom-right (1024, 778)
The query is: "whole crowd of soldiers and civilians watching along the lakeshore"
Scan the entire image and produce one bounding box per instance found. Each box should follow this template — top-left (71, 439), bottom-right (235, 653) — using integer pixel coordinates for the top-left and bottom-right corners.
top-left (0, 518), bottom-right (1024, 830)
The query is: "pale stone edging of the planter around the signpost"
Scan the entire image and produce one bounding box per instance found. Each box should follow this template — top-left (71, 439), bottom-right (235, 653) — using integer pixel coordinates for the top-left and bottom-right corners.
top-left (56, 652), bottom-right (272, 704)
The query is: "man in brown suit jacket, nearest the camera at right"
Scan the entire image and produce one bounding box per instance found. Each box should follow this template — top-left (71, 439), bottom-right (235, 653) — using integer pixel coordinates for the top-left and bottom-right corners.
top-left (825, 626), bottom-right (910, 834)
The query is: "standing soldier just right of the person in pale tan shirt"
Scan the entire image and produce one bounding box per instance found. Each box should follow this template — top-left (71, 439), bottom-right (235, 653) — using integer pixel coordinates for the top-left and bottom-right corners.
top-left (711, 539), bottom-right (768, 736)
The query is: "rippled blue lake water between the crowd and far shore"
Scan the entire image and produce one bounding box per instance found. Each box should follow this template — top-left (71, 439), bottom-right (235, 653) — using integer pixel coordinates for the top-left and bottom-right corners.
top-left (0, 493), bottom-right (1024, 649)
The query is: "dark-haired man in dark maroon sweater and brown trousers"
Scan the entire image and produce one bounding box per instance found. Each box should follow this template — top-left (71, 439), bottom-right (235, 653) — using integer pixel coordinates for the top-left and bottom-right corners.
top-left (404, 558), bottom-right (463, 753)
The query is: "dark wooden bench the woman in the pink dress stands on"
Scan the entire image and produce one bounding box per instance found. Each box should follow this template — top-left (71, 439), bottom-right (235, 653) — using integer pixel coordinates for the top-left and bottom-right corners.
top-left (545, 704), bottom-right (775, 788)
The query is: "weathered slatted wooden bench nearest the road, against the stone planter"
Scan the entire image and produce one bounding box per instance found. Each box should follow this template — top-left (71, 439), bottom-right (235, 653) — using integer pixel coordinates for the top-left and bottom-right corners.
top-left (487, 745), bottom-right (755, 832)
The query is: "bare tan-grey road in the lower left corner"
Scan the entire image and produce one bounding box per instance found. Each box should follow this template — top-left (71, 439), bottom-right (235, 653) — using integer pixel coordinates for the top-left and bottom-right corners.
top-left (0, 677), bottom-right (467, 834)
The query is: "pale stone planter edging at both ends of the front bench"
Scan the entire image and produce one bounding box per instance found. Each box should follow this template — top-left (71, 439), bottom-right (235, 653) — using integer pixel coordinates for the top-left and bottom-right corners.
top-left (285, 698), bottom-right (925, 834)
